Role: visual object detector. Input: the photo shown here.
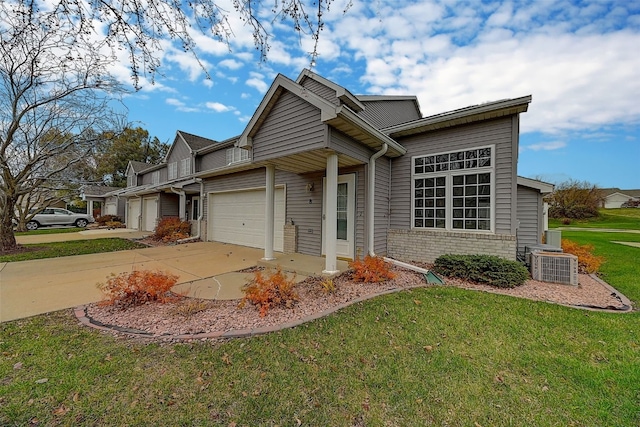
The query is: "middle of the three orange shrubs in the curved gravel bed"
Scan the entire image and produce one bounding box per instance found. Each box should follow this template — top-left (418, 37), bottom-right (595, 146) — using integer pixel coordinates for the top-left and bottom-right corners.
top-left (240, 267), bottom-right (298, 317)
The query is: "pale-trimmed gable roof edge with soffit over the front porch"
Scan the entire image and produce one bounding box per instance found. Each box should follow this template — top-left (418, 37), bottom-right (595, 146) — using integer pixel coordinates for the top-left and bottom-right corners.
top-left (237, 72), bottom-right (406, 157)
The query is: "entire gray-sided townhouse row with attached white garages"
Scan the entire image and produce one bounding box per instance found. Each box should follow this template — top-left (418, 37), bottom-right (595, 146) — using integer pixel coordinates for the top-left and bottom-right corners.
top-left (97, 70), bottom-right (552, 272)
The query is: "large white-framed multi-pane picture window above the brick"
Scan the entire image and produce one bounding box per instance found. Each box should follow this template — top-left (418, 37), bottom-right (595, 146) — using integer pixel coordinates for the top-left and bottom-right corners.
top-left (411, 147), bottom-right (495, 231)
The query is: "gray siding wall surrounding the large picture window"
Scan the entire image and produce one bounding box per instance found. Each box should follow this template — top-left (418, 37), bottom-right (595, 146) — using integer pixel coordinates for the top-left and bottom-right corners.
top-left (390, 117), bottom-right (517, 234)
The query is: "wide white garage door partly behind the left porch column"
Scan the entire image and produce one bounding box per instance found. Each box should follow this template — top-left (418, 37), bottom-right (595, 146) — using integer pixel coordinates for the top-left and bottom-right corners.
top-left (208, 188), bottom-right (285, 251)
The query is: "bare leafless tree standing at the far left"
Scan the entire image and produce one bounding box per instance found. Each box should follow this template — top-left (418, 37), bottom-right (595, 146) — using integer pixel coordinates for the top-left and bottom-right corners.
top-left (0, 7), bottom-right (120, 251)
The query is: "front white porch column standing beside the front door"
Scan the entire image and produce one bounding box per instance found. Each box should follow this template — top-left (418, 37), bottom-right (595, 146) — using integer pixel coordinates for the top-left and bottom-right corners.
top-left (322, 153), bottom-right (338, 274)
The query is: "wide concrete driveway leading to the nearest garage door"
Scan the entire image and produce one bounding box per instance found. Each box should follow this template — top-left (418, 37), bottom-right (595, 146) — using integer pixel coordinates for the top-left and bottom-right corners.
top-left (0, 242), bottom-right (264, 322)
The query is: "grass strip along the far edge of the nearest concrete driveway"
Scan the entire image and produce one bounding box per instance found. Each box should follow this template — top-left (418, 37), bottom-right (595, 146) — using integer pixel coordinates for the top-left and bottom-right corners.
top-left (0, 238), bottom-right (146, 262)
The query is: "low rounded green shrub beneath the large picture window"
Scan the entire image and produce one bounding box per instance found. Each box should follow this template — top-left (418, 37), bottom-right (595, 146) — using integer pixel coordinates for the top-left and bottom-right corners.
top-left (433, 255), bottom-right (529, 288)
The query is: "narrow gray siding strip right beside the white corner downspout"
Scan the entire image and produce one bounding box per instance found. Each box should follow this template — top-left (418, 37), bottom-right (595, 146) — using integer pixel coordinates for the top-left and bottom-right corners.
top-left (373, 157), bottom-right (391, 255)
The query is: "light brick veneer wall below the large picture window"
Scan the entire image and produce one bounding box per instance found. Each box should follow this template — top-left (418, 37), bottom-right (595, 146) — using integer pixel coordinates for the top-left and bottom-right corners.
top-left (387, 229), bottom-right (516, 262)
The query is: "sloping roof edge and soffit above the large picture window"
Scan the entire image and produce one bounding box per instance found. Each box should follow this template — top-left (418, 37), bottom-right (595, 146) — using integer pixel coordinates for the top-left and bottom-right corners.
top-left (382, 95), bottom-right (531, 138)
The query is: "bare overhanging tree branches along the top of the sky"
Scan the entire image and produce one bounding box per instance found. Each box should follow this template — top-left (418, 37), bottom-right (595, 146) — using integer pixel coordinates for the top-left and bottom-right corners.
top-left (5, 0), bottom-right (351, 87)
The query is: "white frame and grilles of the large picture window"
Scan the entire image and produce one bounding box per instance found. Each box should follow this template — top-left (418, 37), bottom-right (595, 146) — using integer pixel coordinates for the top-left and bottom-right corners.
top-left (411, 145), bottom-right (496, 234)
